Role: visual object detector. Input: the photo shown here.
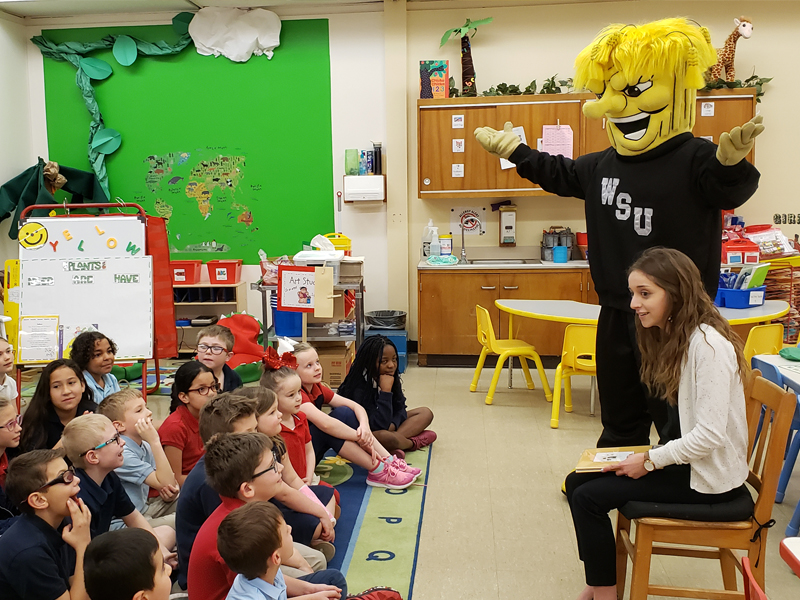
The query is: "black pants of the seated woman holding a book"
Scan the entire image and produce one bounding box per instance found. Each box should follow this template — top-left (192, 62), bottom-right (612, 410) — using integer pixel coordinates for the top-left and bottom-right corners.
top-left (566, 465), bottom-right (740, 586)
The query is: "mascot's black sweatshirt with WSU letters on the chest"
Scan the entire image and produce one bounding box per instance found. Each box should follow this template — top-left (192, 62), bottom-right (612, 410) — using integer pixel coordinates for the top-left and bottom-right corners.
top-left (509, 133), bottom-right (760, 310)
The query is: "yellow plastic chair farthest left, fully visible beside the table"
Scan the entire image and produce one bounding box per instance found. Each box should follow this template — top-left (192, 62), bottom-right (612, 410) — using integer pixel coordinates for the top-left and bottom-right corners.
top-left (469, 305), bottom-right (553, 404)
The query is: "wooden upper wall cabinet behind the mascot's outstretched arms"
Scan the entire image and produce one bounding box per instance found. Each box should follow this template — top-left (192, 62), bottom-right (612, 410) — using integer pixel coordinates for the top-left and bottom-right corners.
top-left (417, 89), bottom-right (755, 198)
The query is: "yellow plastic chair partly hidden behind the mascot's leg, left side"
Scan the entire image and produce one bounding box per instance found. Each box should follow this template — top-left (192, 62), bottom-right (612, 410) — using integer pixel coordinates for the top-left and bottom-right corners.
top-left (550, 325), bottom-right (597, 429)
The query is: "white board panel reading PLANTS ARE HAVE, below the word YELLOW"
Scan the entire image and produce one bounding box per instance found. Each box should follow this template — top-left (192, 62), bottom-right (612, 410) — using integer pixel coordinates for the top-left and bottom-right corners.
top-left (20, 254), bottom-right (153, 359)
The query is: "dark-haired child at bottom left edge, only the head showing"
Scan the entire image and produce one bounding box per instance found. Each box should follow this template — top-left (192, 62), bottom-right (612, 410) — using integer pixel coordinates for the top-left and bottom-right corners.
top-left (83, 529), bottom-right (172, 600)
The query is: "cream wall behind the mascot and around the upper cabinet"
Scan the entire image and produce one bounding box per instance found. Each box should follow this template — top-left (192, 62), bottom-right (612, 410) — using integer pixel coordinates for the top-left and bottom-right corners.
top-left (407, 1), bottom-right (800, 339)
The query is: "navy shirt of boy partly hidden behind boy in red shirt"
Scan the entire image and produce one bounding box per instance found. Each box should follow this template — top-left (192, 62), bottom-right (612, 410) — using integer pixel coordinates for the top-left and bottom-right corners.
top-left (175, 458), bottom-right (222, 590)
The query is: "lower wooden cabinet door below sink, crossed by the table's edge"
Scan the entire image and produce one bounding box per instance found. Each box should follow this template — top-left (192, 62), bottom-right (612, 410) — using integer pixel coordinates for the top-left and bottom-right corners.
top-left (498, 269), bottom-right (584, 356)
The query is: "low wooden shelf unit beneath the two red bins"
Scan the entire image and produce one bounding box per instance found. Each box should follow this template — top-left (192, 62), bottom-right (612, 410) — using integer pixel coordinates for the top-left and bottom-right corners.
top-left (172, 281), bottom-right (247, 354)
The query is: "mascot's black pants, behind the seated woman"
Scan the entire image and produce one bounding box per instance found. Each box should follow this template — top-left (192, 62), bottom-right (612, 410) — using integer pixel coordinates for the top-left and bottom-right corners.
top-left (597, 306), bottom-right (680, 448)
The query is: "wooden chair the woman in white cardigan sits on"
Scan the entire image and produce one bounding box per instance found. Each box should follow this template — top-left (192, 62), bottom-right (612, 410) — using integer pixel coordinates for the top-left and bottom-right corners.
top-left (617, 371), bottom-right (796, 600)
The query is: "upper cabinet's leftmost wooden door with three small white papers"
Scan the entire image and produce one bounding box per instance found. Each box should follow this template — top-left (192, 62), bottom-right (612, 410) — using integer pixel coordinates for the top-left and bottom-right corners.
top-left (418, 105), bottom-right (497, 193)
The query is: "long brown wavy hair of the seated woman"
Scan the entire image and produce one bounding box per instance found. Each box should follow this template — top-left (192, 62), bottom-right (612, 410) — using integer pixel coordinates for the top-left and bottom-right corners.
top-left (628, 248), bottom-right (748, 405)
